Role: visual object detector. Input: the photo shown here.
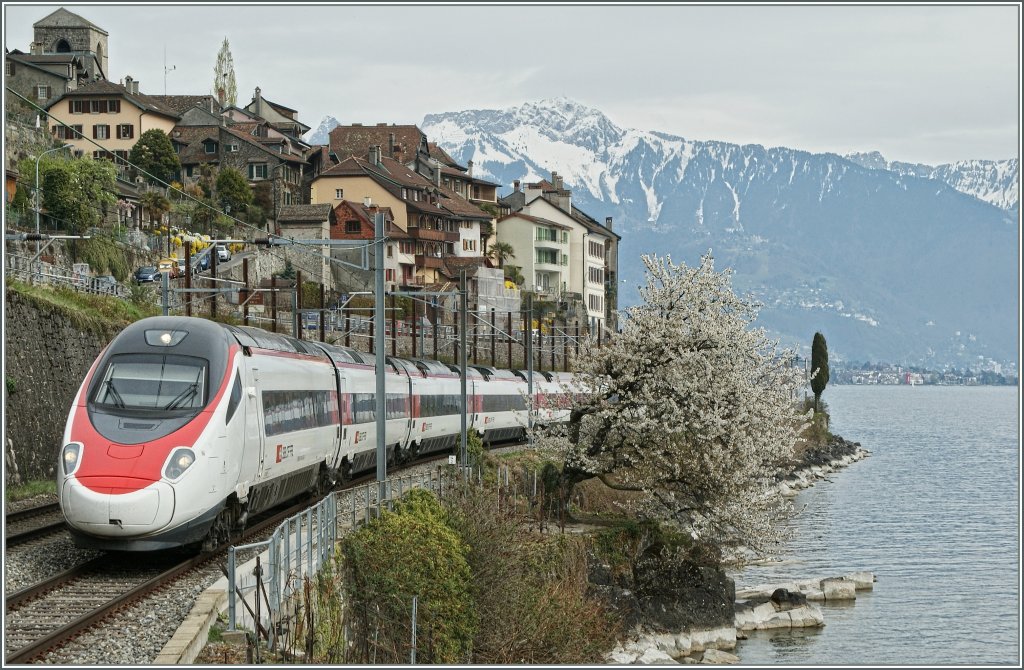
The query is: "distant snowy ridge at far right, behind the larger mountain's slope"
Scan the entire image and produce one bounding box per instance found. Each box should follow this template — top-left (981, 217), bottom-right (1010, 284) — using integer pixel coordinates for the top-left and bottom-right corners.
top-left (846, 152), bottom-right (1020, 215)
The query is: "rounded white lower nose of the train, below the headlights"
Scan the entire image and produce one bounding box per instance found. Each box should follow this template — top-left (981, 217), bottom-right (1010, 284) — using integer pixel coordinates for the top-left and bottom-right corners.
top-left (60, 479), bottom-right (174, 538)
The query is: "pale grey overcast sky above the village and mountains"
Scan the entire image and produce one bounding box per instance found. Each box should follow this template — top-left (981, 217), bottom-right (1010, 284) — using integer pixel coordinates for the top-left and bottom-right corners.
top-left (4, 3), bottom-right (1021, 164)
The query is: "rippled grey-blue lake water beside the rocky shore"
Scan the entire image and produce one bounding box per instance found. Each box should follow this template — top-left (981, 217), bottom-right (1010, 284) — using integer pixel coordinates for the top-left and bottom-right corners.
top-left (733, 386), bottom-right (1021, 667)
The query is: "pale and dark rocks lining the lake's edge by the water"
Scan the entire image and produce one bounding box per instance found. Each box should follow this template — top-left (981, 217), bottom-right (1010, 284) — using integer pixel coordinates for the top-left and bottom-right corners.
top-left (604, 435), bottom-right (876, 665)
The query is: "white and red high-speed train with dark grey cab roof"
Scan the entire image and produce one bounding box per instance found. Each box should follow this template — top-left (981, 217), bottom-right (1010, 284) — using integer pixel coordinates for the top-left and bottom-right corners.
top-left (57, 317), bottom-right (581, 551)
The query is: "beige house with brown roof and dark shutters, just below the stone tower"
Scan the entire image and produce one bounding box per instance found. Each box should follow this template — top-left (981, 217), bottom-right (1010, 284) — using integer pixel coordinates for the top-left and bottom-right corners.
top-left (46, 77), bottom-right (180, 159)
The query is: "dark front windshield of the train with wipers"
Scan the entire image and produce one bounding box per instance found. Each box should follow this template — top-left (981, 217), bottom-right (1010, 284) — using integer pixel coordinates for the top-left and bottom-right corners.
top-left (92, 353), bottom-right (207, 411)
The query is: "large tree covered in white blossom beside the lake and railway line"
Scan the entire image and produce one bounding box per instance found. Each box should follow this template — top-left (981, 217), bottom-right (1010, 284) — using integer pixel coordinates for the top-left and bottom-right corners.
top-left (537, 252), bottom-right (803, 552)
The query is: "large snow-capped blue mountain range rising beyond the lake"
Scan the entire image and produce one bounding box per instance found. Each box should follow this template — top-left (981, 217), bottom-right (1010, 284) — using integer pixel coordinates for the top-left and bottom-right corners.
top-left (421, 98), bottom-right (1019, 364)
